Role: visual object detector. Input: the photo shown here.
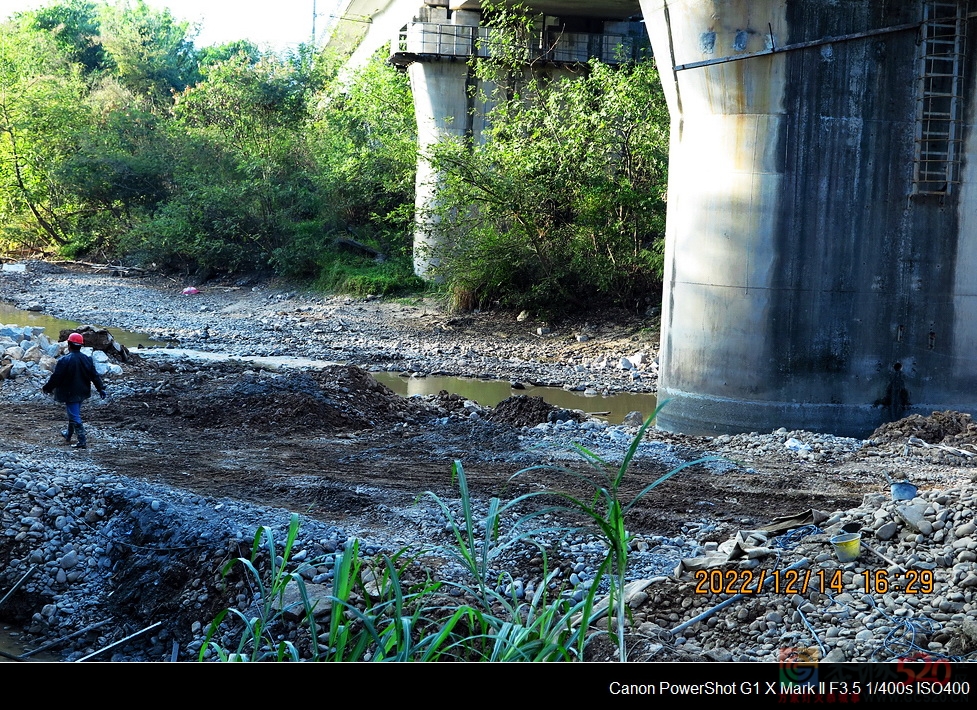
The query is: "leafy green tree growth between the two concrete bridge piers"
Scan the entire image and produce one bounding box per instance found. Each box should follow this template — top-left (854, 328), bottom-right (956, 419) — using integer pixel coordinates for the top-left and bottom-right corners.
top-left (432, 6), bottom-right (668, 312)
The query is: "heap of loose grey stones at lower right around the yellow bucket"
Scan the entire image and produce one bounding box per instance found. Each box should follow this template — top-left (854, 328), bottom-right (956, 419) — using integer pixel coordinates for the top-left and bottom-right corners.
top-left (633, 485), bottom-right (977, 661)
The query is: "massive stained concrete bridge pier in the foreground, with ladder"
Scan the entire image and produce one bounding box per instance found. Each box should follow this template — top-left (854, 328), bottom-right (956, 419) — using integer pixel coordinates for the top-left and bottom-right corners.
top-left (641, 0), bottom-right (977, 436)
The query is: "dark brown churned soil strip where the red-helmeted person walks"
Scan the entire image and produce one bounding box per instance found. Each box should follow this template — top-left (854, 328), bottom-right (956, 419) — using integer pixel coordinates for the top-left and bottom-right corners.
top-left (5, 359), bottom-right (873, 534)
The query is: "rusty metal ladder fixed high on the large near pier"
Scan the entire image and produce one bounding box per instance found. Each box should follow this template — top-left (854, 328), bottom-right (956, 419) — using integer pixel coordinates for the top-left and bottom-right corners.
top-left (913, 0), bottom-right (969, 195)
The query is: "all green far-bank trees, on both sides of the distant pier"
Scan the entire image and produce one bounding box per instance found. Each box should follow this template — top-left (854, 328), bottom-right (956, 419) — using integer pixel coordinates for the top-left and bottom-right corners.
top-left (0, 0), bottom-right (667, 313)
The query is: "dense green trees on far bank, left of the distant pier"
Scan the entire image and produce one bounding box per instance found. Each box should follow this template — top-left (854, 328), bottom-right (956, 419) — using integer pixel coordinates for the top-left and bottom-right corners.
top-left (0, 0), bottom-right (415, 290)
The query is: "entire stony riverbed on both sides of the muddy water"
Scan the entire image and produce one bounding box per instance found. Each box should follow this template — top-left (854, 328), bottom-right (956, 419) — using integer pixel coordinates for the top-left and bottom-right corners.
top-left (0, 263), bottom-right (977, 661)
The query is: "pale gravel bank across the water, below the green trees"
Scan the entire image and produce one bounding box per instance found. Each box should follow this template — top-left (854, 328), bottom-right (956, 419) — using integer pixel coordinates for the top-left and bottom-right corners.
top-left (0, 262), bottom-right (657, 394)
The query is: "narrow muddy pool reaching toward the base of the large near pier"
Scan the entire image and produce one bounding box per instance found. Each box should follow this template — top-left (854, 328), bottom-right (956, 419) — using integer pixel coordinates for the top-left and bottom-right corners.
top-left (373, 372), bottom-right (658, 424)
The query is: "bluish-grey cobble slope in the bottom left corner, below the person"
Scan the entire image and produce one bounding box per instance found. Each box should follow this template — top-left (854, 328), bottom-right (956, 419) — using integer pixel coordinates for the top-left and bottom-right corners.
top-left (0, 452), bottom-right (345, 660)
